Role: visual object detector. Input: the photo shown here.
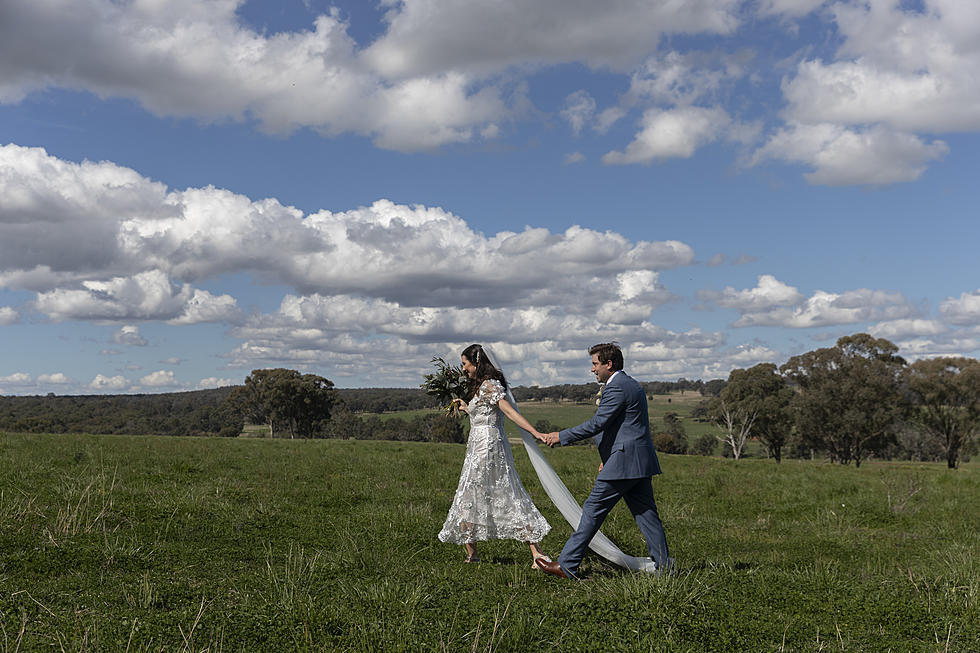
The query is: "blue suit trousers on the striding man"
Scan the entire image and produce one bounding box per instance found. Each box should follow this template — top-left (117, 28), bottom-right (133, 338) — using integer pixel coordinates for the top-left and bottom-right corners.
top-left (558, 477), bottom-right (669, 576)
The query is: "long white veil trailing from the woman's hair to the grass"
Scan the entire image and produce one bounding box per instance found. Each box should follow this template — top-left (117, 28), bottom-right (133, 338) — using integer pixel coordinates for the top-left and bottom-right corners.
top-left (483, 345), bottom-right (657, 574)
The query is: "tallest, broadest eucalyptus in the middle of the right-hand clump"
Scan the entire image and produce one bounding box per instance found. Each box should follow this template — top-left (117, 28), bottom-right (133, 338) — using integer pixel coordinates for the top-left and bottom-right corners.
top-left (780, 333), bottom-right (907, 466)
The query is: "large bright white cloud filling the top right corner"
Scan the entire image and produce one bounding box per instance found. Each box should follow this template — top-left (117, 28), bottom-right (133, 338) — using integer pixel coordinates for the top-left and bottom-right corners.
top-left (784, 0), bottom-right (980, 132)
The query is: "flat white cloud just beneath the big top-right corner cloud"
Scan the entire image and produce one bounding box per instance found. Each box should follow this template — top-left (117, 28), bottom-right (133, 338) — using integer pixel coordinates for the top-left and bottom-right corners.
top-left (751, 123), bottom-right (949, 186)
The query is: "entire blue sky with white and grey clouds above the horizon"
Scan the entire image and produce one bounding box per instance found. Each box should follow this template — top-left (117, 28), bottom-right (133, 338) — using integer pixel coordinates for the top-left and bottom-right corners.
top-left (0, 0), bottom-right (980, 395)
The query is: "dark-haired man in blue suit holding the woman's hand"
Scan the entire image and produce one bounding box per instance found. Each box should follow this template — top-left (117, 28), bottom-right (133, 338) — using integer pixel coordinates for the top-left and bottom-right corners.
top-left (534, 343), bottom-right (674, 578)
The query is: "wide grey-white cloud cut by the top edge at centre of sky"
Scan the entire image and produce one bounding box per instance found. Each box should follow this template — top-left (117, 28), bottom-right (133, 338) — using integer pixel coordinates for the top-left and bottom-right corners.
top-left (365, 0), bottom-right (739, 77)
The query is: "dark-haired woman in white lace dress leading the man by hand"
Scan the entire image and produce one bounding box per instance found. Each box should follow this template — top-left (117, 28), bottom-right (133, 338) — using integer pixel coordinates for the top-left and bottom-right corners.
top-left (439, 345), bottom-right (551, 569)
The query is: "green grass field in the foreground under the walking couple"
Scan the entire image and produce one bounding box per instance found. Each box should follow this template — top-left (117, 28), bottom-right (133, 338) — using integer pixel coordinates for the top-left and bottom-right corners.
top-left (0, 434), bottom-right (980, 651)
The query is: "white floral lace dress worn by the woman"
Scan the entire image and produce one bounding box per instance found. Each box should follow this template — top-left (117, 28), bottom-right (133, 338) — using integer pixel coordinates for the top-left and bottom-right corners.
top-left (439, 379), bottom-right (551, 544)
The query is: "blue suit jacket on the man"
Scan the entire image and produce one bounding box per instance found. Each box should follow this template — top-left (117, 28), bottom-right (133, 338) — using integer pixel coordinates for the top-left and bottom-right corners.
top-left (558, 371), bottom-right (660, 481)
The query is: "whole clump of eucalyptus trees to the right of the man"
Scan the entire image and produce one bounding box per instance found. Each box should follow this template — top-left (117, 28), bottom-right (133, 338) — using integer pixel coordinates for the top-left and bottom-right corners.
top-left (697, 333), bottom-right (980, 468)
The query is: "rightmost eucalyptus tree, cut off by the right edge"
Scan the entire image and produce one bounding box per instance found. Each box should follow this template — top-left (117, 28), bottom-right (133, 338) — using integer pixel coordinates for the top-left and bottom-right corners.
top-left (903, 357), bottom-right (980, 469)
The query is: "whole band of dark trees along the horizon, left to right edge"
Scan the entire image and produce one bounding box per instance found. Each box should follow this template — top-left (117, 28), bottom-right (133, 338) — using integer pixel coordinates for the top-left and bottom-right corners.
top-left (7, 333), bottom-right (980, 468)
